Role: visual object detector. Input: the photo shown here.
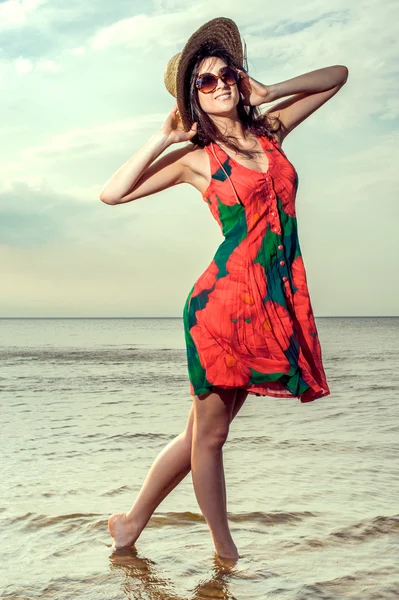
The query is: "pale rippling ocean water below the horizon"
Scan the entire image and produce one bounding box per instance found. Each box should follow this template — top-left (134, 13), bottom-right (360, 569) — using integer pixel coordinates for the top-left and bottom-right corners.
top-left (0, 318), bottom-right (399, 600)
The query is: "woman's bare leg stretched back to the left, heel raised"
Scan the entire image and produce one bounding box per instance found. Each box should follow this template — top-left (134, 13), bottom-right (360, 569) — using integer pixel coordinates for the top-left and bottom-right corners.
top-left (108, 389), bottom-right (248, 548)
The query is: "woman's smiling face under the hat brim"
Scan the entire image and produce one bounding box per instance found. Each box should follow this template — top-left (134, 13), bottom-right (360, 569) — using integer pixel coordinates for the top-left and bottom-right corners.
top-left (196, 56), bottom-right (240, 117)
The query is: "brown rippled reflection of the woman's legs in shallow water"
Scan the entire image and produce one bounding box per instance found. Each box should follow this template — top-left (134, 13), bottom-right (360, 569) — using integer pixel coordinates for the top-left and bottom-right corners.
top-left (110, 547), bottom-right (237, 600)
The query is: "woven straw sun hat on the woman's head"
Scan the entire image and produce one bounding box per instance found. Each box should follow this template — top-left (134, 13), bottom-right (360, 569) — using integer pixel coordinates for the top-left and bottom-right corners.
top-left (164, 17), bottom-right (246, 131)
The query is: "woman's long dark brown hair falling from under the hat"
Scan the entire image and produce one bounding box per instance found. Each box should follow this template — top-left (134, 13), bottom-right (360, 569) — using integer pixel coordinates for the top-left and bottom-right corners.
top-left (184, 43), bottom-right (281, 158)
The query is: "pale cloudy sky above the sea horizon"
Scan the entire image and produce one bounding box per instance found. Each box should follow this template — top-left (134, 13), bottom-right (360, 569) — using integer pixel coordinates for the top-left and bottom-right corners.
top-left (0, 0), bottom-right (399, 317)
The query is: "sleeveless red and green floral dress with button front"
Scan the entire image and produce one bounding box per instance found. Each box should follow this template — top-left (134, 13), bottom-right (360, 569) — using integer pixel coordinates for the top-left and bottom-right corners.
top-left (183, 136), bottom-right (330, 402)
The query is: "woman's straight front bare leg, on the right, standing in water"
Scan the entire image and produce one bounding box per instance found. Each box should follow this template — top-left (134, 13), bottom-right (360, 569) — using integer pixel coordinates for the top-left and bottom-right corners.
top-left (191, 388), bottom-right (239, 559)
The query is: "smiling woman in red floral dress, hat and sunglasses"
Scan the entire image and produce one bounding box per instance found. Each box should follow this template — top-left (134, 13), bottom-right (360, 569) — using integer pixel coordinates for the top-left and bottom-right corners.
top-left (100, 18), bottom-right (348, 559)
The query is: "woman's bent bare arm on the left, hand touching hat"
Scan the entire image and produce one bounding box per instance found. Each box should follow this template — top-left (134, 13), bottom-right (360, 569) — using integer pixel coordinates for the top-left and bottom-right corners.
top-left (100, 105), bottom-right (197, 204)
